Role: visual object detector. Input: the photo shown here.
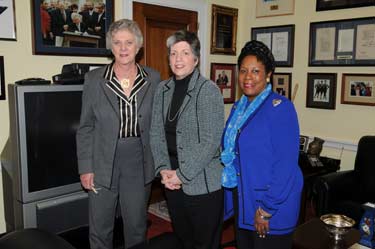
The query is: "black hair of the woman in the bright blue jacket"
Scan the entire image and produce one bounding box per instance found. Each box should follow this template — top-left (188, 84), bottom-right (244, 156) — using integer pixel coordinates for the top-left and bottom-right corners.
top-left (237, 40), bottom-right (275, 74)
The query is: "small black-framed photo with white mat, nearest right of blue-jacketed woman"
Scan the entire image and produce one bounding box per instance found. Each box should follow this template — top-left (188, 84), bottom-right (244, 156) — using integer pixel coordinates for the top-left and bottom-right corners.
top-left (306, 73), bottom-right (337, 109)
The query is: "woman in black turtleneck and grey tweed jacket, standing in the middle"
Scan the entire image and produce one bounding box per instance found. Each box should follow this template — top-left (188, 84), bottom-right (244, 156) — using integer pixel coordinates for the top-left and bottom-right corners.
top-left (150, 31), bottom-right (224, 249)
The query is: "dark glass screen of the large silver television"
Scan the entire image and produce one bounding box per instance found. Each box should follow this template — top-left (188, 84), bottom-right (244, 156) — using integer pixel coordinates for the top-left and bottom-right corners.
top-left (24, 91), bottom-right (82, 192)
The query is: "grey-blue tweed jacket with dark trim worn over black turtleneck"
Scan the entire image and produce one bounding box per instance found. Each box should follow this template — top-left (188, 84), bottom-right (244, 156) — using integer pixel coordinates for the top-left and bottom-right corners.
top-left (150, 69), bottom-right (224, 195)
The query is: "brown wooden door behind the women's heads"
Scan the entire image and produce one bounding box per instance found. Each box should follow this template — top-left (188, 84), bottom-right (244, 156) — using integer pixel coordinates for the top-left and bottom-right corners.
top-left (133, 2), bottom-right (198, 80)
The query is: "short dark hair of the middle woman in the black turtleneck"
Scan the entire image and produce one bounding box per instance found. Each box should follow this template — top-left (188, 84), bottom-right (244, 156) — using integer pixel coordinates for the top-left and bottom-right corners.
top-left (167, 30), bottom-right (201, 60)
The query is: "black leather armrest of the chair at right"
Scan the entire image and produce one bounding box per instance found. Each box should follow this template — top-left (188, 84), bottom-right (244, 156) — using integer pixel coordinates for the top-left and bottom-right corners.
top-left (313, 170), bottom-right (358, 216)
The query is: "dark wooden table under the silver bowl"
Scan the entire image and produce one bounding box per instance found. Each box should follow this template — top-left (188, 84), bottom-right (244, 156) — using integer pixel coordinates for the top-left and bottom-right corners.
top-left (293, 218), bottom-right (360, 249)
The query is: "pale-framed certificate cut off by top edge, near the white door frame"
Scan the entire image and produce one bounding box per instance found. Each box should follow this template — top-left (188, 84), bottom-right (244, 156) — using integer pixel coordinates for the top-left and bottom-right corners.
top-left (255, 0), bottom-right (294, 17)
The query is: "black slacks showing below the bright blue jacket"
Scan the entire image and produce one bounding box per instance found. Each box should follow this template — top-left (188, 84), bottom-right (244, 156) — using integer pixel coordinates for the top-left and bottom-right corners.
top-left (233, 188), bottom-right (293, 249)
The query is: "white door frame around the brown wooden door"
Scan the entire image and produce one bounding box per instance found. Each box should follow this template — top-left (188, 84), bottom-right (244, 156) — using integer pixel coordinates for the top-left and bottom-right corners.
top-left (122, 0), bottom-right (209, 75)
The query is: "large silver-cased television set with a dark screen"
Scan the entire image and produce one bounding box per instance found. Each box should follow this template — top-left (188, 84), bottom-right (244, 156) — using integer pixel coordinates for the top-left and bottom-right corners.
top-left (2, 84), bottom-right (83, 203)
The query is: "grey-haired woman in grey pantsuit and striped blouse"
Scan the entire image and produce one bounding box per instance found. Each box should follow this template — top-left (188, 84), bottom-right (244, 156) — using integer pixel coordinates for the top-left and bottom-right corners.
top-left (77, 19), bottom-right (160, 249)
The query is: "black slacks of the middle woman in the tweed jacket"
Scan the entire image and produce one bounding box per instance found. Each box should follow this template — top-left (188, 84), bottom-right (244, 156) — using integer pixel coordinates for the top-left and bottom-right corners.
top-left (165, 189), bottom-right (223, 249)
